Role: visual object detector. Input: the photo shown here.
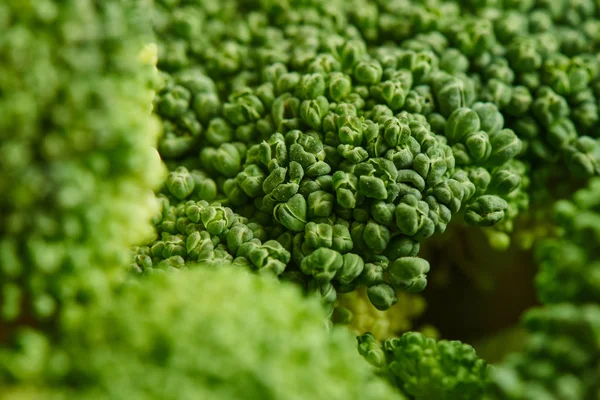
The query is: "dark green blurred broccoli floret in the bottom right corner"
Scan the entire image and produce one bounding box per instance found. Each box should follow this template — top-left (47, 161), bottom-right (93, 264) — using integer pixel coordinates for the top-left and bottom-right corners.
top-left (486, 303), bottom-right (600, 400)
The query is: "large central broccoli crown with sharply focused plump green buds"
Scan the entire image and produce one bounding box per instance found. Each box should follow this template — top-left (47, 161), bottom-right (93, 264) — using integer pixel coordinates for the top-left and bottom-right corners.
top-left (134, 2), bottom-right (540, 316)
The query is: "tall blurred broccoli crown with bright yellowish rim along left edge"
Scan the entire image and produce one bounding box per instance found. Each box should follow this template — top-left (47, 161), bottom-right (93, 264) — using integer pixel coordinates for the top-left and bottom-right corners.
top-left (0, 0), bottom-right (163, 334)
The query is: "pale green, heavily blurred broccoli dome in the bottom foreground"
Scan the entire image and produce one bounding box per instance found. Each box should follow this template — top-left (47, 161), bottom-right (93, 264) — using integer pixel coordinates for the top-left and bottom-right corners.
top-left (3, 266), bottom-right (398, 400)
